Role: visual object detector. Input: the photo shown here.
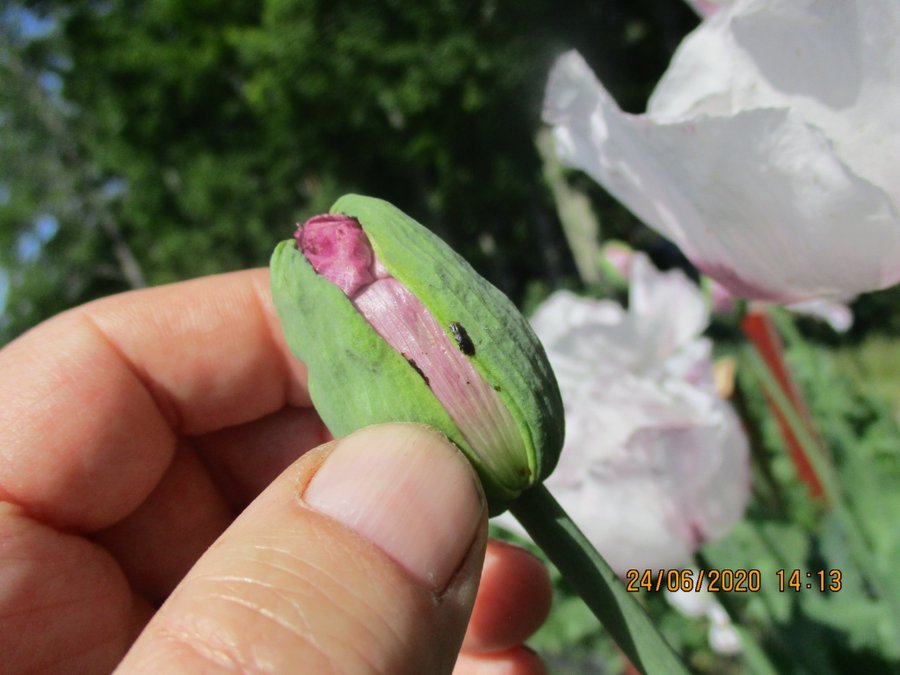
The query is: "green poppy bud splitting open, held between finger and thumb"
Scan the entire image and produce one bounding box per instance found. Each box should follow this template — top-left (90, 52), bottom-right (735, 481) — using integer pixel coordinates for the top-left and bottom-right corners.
top-left (271, 195), bottom-right (563, 513)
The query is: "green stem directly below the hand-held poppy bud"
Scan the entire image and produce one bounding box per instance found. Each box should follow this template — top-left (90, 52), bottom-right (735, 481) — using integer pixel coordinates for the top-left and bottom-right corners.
top-left (510, 485), bottom-right (688, 675)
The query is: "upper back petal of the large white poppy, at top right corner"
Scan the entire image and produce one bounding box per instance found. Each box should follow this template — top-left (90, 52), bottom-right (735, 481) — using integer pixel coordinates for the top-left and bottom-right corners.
top-left (647, 0), bottom-right (900, 205)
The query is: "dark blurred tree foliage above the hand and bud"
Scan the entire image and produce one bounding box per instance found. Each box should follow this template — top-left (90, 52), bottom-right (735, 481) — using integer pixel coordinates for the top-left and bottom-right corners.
top-left (0, 0), bottom-right (697, 342)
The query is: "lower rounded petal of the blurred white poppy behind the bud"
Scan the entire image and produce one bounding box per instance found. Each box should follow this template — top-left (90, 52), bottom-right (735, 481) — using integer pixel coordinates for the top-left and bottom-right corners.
top-left (532, 374), bottom-right (750, 574)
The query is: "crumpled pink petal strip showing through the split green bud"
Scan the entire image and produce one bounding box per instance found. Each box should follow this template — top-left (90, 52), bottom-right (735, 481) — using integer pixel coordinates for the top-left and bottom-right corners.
top-left (297, 216), bottom-right (526, 485)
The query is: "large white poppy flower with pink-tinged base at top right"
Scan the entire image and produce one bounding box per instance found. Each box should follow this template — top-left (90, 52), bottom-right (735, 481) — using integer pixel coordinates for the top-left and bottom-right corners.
top-left (544, 0), bottom-right (900, 303)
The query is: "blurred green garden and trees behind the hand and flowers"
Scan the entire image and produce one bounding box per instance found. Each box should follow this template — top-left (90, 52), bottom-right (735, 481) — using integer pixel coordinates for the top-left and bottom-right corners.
top-left (0, 0), bottom-right (900, 673)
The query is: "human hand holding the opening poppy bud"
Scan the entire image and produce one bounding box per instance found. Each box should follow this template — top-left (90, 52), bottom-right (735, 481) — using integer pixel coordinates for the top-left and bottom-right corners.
top-left (0, 270), bottom-right (550, 675)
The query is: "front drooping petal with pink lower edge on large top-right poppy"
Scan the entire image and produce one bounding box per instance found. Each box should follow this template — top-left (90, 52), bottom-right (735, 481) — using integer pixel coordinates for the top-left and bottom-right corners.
top-left (545, 53), bottom-right (900, 302)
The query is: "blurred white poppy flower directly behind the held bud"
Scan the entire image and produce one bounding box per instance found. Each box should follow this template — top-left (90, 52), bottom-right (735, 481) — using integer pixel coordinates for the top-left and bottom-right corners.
top-left (500, 254), bottom-right (749, 575)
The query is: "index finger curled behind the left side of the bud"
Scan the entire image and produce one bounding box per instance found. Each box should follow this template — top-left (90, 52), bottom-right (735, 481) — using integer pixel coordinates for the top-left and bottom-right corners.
top-left (0, 269), bottom-right (310, 530)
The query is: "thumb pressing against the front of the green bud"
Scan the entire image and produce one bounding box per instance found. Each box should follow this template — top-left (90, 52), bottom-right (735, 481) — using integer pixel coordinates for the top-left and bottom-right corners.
top-left (119, 424), bottom-right (487, 673)
